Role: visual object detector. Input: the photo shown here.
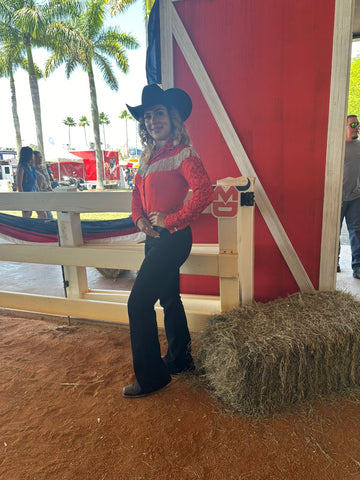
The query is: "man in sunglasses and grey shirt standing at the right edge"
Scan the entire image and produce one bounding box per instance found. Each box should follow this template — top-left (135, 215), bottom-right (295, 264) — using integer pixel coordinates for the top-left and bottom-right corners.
top-left (338, 115), bottom-right (360, 280)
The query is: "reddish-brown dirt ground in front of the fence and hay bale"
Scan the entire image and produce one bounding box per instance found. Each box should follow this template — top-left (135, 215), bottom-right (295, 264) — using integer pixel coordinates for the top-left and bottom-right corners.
top-left (0, 312), bottom-right (360, 480)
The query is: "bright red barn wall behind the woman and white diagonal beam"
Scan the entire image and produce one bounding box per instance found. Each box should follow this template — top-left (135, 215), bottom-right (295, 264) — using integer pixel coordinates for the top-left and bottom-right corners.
top-left (174, 0), bottom-right (335, 300)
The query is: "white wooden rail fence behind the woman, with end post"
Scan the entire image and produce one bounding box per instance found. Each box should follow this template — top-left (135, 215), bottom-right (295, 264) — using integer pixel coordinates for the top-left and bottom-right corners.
top-left (0, 177), bottom-right (254, 331)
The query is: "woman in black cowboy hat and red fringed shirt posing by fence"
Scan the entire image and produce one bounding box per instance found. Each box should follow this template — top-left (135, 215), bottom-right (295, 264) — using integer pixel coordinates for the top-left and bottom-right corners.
top-left (123, 85), bottom-right (213, 398)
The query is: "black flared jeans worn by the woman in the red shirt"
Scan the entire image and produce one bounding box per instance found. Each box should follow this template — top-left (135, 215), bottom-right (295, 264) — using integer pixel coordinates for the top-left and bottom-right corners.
top-left (128, 227), bottom-right (192, 392)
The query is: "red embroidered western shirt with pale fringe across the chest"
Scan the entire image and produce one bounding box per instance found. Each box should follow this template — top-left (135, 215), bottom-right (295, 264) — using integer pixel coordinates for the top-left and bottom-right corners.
top-left (132, 140), bottom-right (214, 232)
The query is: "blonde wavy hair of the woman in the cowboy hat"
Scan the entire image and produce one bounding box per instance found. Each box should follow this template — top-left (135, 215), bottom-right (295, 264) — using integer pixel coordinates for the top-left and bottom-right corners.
top-left (139, 107), bottom-right (191, 165)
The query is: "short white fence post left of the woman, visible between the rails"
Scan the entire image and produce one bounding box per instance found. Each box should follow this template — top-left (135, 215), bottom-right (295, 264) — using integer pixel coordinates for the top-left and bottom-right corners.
top-left (57, 212), bottom-right (89, 298)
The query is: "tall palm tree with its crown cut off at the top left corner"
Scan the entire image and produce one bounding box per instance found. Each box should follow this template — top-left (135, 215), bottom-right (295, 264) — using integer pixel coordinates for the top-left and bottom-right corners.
top-left (0, 0), bottom-right (80, 159)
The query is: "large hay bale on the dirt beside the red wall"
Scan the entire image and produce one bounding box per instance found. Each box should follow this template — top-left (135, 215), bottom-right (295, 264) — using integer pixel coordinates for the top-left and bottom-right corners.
top-left (195, 292), bottom-right (360, 415)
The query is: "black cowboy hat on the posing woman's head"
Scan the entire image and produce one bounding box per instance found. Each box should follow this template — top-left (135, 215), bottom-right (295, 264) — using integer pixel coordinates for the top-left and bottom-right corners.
top-left (126, 84), bottom-right (192, 122)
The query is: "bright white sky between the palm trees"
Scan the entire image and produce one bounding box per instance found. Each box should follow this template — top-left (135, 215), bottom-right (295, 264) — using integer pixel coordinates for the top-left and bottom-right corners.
top-left (0, 1), bottom-right (147, 159)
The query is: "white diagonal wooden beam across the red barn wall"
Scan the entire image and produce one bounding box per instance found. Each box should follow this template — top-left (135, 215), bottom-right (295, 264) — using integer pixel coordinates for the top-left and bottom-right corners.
top-left (167, 0), bottom-right (314, 292)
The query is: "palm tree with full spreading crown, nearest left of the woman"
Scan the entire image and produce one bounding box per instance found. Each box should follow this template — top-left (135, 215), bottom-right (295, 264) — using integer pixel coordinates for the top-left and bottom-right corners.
top-left (45, 0), bottom-right (139, 189)
